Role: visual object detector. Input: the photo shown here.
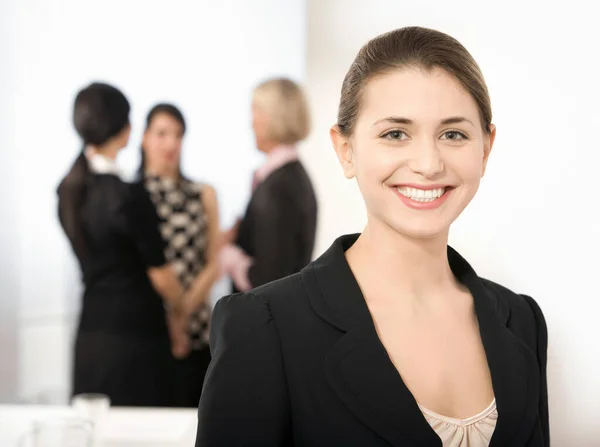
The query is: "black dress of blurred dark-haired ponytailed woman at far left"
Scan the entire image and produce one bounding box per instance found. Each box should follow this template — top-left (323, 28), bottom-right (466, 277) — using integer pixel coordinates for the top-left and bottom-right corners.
top-left (59, 174), bottom-right (172, 406)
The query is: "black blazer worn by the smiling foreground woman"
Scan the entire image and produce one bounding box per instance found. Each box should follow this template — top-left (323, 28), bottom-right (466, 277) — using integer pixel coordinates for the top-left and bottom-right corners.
top-left (196, 235), bottom-right (550, 447)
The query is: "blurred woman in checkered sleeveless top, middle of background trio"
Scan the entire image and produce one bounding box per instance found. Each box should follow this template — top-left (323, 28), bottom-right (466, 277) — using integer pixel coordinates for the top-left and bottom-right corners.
top-left (139, 104), bottom-right (219, 407)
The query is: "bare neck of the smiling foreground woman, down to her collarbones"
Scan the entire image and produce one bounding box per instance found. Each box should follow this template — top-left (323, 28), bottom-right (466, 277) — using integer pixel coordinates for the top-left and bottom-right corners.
top-left (347, 221), bottom-right (455, 301)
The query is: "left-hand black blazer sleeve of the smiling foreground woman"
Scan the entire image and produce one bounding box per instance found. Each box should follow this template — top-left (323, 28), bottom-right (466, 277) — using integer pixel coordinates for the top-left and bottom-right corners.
top-left (196, 293), bottom-right (291, 447)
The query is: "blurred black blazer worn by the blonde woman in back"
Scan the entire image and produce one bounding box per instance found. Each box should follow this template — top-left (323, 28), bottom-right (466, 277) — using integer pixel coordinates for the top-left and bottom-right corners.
top-left (234, 161), bottom-right (317, 292)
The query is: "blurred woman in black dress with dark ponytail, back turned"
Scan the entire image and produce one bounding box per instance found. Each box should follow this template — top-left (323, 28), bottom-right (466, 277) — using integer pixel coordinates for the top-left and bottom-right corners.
top-left (58, 83), bottom-right (188, 406)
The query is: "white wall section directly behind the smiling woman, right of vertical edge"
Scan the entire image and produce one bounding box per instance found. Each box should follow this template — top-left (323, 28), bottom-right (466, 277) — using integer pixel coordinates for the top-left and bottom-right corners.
top-left (304, 0), bottom-right (600, 447)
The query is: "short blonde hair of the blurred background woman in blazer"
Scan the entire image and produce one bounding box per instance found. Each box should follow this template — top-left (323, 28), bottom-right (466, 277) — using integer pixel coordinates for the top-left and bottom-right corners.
top-left (252, 78), bottom-right (310, 144)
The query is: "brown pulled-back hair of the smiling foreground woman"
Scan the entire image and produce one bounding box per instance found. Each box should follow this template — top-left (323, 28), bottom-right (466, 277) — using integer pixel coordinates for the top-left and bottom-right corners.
top-left (337, 26), bottom-right (492, 137)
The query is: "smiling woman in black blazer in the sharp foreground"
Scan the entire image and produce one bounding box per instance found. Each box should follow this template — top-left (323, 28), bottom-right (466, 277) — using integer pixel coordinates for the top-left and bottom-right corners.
top-left (196, 27), bottom-right (550, 447)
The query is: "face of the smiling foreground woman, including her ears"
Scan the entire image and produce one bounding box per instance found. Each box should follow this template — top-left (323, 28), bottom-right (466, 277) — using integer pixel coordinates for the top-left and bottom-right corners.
top-left (331, 69), bottom-right (495, 242)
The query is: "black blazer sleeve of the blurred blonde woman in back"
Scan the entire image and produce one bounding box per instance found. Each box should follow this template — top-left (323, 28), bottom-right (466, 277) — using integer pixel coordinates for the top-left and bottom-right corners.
top-left (248, 183), bottom-right (298, 287)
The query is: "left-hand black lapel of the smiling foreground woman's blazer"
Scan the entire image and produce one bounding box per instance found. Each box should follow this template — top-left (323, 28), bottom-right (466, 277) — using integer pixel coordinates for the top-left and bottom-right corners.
top-left (302, 236), bottom-right (442, 447)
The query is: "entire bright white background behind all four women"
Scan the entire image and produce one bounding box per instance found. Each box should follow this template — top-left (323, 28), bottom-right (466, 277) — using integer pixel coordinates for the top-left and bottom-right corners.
top-left (0, 0), bottom-right (600, 446)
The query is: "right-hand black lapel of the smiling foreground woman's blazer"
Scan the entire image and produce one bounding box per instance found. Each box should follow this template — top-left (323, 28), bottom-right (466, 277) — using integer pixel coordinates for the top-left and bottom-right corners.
top-left (448, 248), bottom-right (540, 447)
